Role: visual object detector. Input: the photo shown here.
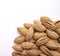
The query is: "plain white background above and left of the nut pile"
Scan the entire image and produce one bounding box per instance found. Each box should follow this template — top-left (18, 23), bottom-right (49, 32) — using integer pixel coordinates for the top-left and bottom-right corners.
top-left (0, 0), bottom-right (60, 56)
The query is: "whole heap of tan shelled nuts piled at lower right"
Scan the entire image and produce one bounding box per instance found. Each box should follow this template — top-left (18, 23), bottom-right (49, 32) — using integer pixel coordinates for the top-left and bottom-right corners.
top-left (12, 16), bottom-right (60, 56)
